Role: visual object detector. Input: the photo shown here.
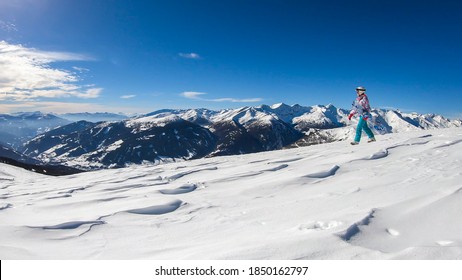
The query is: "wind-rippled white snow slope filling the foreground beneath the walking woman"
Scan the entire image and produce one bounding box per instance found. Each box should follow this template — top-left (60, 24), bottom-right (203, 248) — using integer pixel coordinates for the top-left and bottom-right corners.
top-left (0, 128), bottom-right (462, 259)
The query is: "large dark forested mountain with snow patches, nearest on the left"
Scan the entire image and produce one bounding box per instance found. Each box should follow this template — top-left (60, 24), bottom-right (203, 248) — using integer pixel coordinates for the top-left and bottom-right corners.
top-left (23, 117), bottom-right (216, 169)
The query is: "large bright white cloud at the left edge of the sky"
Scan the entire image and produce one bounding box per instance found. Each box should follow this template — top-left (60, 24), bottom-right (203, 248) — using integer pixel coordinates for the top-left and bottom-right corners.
top-left (0, 41), bottom-right (102, 101)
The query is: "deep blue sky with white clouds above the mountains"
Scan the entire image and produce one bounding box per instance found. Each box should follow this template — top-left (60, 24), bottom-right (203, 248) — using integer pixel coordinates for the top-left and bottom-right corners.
top-left (0, 0), bottom-right (462, 118)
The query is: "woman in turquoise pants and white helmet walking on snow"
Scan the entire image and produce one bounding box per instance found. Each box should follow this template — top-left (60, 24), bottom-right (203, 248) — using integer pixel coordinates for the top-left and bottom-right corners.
top-left (348, 87), bottom-right (375, 145)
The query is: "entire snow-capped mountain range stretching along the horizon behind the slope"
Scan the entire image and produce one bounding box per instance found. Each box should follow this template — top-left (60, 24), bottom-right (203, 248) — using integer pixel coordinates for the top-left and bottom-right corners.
top-left (0, 104), bottom-right (462, 170)
